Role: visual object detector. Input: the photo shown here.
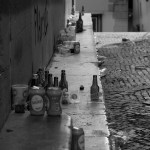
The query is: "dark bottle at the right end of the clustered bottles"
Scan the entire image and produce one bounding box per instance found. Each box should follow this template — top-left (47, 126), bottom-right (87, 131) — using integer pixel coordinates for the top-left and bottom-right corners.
top-left (59, 70), bottom-right (68, 92)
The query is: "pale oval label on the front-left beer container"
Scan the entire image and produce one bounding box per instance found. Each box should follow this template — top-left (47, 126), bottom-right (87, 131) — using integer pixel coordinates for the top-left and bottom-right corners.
top-left (31, 95), bottom-right (44, 112)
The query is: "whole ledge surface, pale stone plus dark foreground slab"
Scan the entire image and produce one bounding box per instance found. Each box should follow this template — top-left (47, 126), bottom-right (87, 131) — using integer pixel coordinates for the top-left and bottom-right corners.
top-left (0, 14), bottom-right (109, 150)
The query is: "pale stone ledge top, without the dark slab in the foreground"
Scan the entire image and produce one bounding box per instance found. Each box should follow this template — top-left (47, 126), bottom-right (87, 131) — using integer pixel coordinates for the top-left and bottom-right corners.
top-left (48, 14), bottom-right (109, 150)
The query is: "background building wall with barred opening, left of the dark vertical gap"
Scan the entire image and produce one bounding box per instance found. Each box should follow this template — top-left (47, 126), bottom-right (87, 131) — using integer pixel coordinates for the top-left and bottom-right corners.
top-left (76, 0), bottom-right (128, 32)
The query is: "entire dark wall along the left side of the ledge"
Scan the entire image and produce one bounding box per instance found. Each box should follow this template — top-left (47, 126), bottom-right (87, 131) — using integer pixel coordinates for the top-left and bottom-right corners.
top-left (0, 0), bottom-right (68, 129)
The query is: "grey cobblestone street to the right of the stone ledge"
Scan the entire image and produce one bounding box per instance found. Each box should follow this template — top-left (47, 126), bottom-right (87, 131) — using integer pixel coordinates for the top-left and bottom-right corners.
top-left (95, 33), bottom-right (150, 150)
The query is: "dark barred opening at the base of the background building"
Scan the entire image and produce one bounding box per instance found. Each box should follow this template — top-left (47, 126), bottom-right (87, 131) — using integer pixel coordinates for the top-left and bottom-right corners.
top-left (92, 14), bottom-right (102, 32)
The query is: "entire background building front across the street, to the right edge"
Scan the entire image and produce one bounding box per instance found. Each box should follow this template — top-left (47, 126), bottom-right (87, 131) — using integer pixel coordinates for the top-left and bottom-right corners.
top-left (76, 0), bottom-right (150, 32)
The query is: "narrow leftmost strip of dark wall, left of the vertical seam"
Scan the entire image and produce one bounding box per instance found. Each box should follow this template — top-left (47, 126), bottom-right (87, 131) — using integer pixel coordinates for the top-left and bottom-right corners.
top-left (0, 0), bottom-right (10, 132)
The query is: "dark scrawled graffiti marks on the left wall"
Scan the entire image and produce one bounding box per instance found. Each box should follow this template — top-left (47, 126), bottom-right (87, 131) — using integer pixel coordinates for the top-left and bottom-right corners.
top-left (34, 0), bottom-right (48, 44)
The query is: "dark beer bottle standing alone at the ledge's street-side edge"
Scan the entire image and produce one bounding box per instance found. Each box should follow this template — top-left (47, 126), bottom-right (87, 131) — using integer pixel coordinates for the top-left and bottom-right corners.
top-left (90, 75), bottom-right (99, 101)
